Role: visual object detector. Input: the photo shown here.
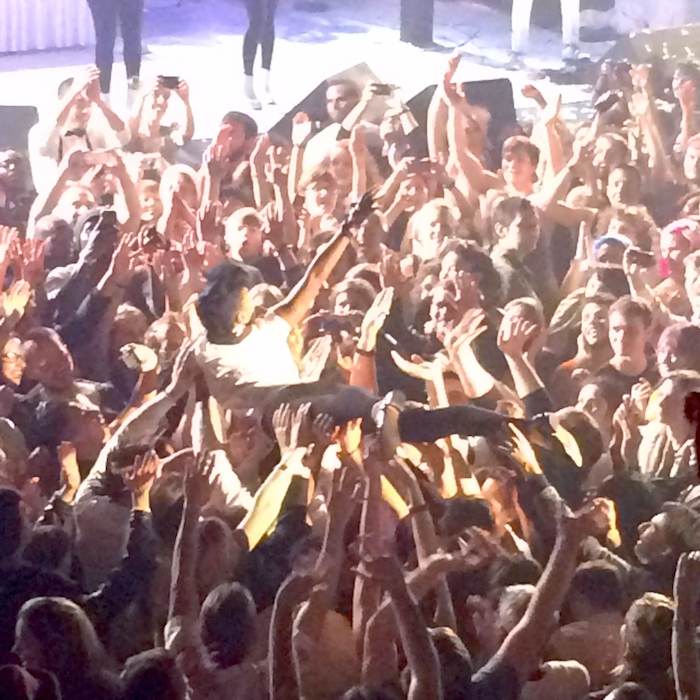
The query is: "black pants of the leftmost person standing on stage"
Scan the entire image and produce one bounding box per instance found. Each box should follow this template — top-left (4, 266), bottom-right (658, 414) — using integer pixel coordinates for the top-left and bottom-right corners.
top-left (88, 0), bottom-right (144, 93)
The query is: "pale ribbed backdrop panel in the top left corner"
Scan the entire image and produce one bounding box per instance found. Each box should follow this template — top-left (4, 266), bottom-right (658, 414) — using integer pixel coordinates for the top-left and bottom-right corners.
top-left (0, 0), bottom-right (94, 53)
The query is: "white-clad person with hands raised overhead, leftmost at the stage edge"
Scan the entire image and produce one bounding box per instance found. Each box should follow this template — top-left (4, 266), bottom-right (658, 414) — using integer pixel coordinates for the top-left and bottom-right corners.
top-left (28, 66), bottom-right (129, 194)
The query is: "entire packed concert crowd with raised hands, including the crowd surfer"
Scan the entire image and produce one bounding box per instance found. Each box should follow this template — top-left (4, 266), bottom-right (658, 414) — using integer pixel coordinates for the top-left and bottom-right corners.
top-left (0, 49), bottom-right (700, 700)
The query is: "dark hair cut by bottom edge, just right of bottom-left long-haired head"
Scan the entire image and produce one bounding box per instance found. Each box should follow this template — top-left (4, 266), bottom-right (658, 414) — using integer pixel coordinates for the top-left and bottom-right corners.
top-left (121, 649), bottom-right (186, 700)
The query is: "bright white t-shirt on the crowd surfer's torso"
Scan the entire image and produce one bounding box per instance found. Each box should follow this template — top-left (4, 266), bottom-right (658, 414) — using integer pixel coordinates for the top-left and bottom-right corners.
top-left (197, 313), bottom-right (302, 408)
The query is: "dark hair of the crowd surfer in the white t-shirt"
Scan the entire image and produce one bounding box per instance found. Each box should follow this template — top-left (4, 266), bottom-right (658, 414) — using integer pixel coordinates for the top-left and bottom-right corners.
top-left (197, 260), bottom-right (251, 342)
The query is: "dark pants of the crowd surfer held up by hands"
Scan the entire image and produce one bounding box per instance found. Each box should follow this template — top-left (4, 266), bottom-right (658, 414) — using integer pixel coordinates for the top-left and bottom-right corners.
top-left (263, 382), bottom-right (518, 442)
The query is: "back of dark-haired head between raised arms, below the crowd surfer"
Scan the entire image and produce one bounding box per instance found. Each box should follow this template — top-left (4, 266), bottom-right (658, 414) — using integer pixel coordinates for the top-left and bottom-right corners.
top-left (199, 583), bottom-right (255, 668)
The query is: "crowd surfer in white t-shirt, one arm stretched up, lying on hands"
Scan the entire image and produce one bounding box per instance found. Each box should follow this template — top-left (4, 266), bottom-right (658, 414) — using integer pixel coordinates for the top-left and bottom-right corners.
top-left (194, 196), bottom-right (540, 442)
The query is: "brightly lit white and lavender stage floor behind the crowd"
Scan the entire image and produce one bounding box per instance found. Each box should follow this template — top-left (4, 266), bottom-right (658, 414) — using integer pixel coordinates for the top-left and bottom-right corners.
top-left (0, 0), bottom-right (606, 138)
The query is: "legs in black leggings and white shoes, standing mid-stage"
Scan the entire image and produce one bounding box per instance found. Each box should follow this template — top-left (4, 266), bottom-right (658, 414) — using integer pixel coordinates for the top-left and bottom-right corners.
top-left (243, 0), bottom-right (278, 109)
